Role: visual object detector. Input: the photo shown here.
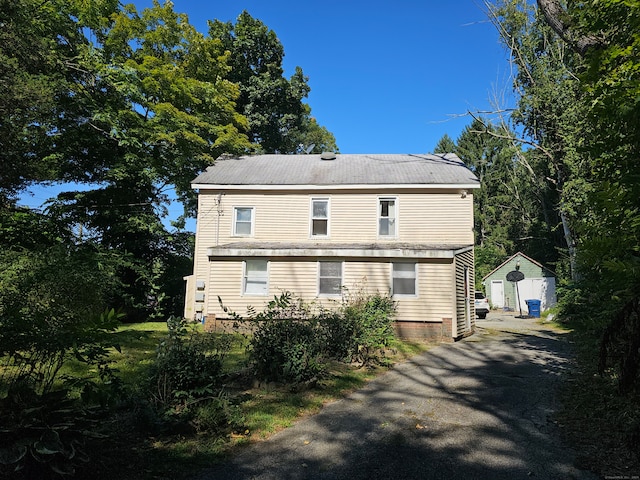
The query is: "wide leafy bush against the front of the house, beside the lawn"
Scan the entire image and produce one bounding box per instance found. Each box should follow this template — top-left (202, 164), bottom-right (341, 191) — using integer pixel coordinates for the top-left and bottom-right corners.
top-left (238, 290), bottom-right (395, 383)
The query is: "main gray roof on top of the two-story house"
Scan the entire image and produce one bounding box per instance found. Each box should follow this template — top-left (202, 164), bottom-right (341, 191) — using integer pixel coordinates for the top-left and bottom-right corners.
top-left (192, 154), bottom-right (480, 188)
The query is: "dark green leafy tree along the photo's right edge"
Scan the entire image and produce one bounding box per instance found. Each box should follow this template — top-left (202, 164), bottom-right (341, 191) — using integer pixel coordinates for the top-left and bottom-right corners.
top-left (539, 0), bottom-right (640, 394)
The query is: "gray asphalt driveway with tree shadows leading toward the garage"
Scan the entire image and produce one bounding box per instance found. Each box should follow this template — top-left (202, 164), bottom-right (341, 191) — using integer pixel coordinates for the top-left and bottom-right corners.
top-left (197, 313), bottom-right (597, 480)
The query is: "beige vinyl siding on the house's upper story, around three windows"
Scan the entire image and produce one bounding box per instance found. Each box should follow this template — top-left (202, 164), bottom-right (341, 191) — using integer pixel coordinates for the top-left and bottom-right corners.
top-left (198, 190), bottom-right (473, 246)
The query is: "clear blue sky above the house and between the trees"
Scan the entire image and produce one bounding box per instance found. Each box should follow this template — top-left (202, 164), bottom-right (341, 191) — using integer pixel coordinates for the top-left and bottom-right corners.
top-left (20, 0), bottom-right (510, 227)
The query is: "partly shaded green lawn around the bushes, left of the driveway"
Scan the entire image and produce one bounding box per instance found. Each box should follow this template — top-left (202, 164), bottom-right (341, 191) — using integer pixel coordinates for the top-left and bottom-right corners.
top-left (5, 322), bottom-right (428, 480)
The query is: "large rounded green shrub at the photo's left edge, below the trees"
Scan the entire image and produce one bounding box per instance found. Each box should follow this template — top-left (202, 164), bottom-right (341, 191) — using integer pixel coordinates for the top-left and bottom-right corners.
top-left (0, 247), bottom-right (121, 394)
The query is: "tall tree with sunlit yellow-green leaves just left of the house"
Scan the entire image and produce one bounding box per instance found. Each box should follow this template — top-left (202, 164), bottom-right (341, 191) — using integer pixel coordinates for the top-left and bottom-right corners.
top-left (37, 3), bottom-right (250, 320)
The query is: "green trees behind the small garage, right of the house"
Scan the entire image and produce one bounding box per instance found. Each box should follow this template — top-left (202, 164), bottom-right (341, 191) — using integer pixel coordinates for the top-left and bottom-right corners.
top-left (440, 117), bottom-right (561, 284)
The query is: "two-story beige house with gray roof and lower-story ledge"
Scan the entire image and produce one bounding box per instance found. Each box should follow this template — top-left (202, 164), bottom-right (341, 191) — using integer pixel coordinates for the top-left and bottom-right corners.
top-left (185, 153), bottom-right (479, 341)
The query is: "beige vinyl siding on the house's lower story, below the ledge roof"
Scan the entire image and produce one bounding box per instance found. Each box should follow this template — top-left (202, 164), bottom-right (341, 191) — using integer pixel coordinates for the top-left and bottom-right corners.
top-left (207, 258), bottom-right (455, 322)
